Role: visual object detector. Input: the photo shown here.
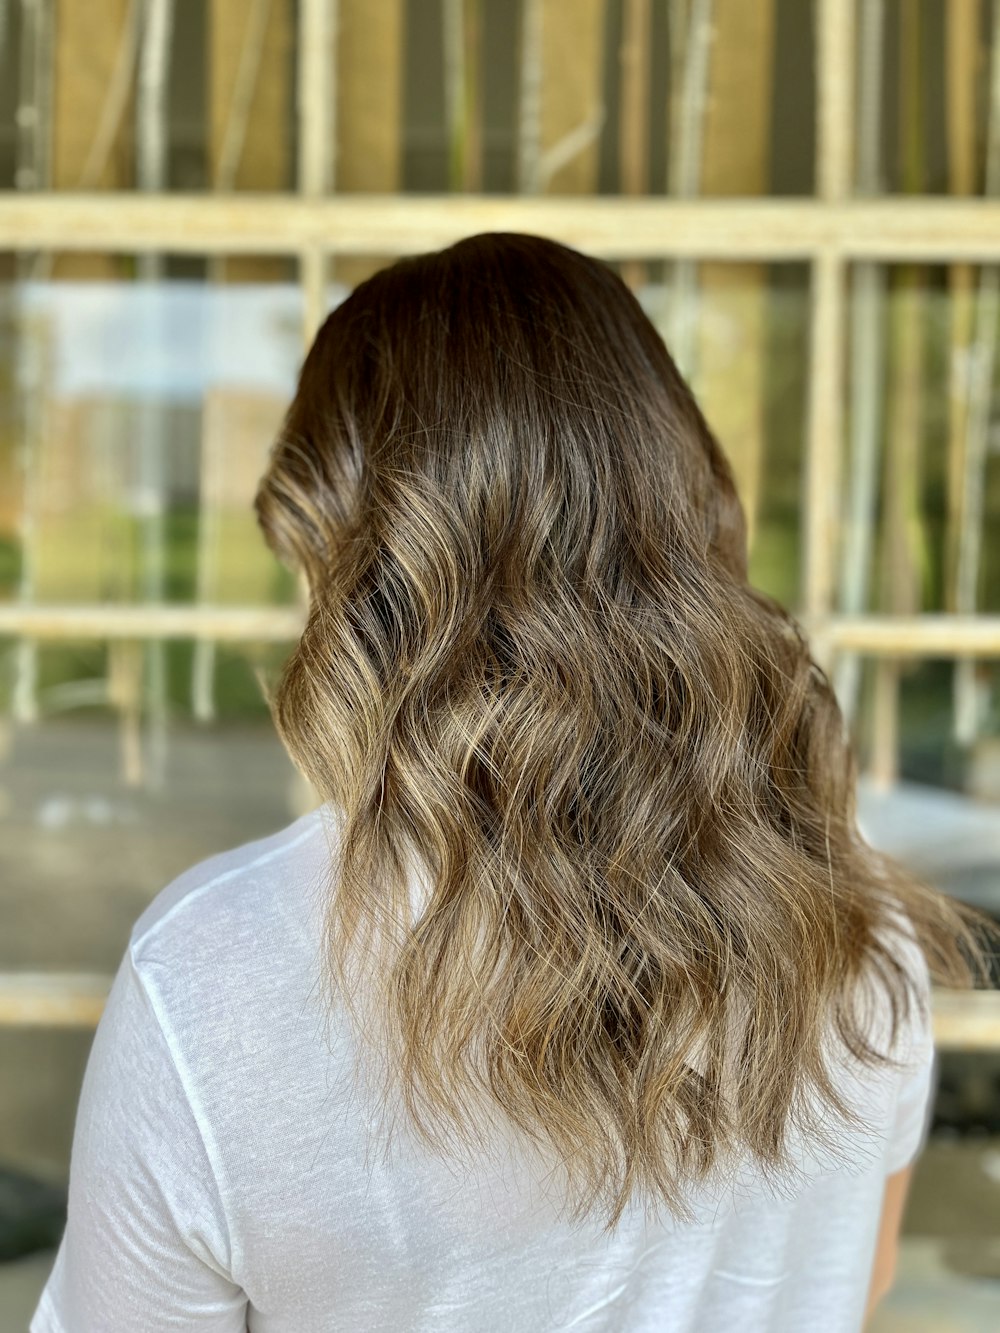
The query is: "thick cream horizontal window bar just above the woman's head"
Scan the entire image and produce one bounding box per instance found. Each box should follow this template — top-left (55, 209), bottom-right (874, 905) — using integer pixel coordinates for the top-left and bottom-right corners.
top-left (0, 191), bottom-right (1000, 263)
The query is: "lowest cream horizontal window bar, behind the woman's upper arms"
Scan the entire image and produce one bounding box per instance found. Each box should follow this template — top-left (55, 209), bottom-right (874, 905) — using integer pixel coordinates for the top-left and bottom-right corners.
top-left (0, 972), bottom-right (1000, 1050)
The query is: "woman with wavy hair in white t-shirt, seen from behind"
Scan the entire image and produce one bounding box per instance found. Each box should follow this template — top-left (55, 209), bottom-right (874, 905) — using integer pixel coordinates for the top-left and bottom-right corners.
top-left (32, 235), bottom-right (985, 1333)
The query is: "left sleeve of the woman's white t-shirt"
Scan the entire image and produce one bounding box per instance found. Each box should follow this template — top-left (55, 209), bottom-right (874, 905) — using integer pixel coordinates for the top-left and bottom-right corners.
top-left (29, 948), bottom-right (247, 1333)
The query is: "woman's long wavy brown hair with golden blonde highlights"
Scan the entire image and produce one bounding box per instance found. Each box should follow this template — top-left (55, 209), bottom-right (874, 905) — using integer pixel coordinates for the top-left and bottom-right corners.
top-left (255, 233), bottom-right (991, 1229)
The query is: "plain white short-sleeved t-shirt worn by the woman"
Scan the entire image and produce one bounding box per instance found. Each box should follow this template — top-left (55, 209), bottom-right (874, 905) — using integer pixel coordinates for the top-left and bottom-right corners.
top-left (31, 806), bottom-right (933, 1333)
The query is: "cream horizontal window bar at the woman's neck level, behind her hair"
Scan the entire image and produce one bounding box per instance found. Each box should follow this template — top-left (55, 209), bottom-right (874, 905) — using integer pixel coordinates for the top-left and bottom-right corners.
top-left (0, 603), bottom-right (1000, 659)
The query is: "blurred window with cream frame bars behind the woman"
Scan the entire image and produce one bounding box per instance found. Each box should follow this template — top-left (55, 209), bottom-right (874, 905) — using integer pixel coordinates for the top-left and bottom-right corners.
top-left (0, 0), bottom-right (1000, 1333)
